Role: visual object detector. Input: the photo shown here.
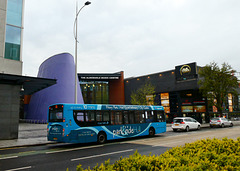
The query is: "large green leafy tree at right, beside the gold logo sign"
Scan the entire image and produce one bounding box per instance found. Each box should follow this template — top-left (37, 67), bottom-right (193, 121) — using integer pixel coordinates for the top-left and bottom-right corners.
top-left (198, 62), bottom-right (238, 114)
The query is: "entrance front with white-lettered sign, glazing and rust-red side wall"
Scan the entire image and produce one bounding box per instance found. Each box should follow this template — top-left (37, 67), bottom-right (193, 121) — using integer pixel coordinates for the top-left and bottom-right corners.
top-left (78, 71), bottom-right (125, 104)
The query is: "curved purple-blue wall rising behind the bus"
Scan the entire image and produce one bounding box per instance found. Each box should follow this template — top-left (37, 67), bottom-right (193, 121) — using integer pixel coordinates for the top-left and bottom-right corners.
top-left (26, 53), bottom-right (84, 122)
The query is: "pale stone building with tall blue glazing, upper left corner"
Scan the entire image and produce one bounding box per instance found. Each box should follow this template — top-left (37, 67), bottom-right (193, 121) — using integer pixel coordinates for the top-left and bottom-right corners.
top-left (0, 0), bottom-right (24, 75)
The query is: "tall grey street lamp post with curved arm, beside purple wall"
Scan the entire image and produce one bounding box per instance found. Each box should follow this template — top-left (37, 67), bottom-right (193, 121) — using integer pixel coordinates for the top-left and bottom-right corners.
top-left (74, 1), bottom-right (91, 104)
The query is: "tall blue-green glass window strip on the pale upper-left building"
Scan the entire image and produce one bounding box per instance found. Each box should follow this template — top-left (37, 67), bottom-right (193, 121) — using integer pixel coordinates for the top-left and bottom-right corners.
top-left (4, 0), bottom-right (23, 61)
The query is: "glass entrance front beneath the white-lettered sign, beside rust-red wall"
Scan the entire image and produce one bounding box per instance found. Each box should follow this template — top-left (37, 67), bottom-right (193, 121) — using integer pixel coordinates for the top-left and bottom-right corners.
top-left (80, 81), bottom-right (109, 104)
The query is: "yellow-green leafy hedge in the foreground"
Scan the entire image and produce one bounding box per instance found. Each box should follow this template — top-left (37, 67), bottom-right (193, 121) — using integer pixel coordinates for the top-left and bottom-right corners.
top-left (77, 137), bottom-right (240, 171)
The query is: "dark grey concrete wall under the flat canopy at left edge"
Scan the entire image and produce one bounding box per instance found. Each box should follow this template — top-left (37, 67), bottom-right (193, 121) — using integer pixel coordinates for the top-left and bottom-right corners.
top-left (0, 84), bottom-right (20, 140)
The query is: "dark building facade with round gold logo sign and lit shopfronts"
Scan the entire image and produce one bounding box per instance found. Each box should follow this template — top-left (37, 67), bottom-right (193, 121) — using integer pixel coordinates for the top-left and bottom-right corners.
top-left (124, 63), bottom-right (240, 123)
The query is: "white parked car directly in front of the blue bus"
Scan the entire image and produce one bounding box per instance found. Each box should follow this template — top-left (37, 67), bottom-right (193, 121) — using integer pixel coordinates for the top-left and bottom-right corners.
top-left (172, 117), bottom-right (201, 132)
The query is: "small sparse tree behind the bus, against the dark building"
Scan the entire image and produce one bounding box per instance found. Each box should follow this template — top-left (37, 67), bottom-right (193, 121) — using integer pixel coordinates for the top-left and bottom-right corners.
top-left (131, 82), bottom-right (155, 105)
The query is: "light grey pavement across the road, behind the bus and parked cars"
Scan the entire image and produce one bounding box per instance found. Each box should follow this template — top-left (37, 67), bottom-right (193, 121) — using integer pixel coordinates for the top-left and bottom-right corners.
top-left (0, 121), bottom-right (240, 149)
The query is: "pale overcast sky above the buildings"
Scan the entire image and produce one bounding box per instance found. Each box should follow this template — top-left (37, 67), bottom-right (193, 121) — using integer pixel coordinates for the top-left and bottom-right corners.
top-left (23, 0), bottom-right (240, 78)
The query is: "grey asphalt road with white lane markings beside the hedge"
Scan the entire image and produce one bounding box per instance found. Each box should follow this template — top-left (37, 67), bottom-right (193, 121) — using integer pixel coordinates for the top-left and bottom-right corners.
top-left (0, 126), bottom-right (240, 171)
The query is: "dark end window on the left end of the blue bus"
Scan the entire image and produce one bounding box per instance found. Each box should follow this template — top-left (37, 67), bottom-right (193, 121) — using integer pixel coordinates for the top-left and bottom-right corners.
top-left (49, 105), bottom-right (63, 122)
